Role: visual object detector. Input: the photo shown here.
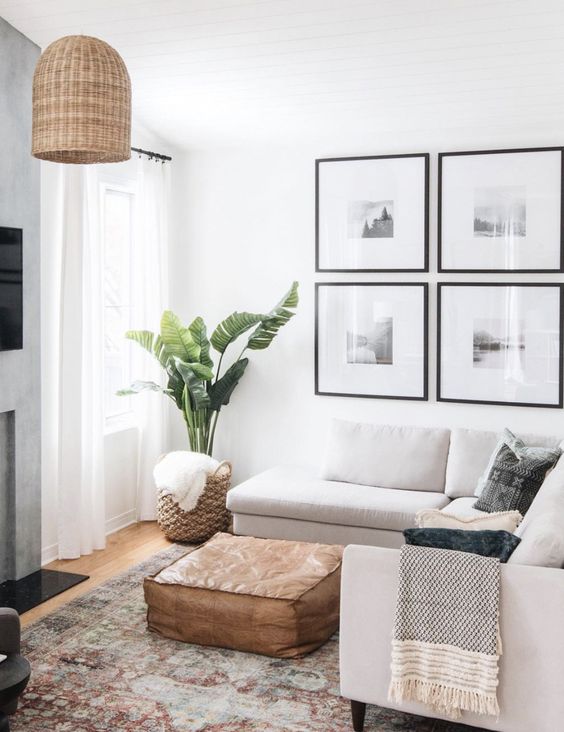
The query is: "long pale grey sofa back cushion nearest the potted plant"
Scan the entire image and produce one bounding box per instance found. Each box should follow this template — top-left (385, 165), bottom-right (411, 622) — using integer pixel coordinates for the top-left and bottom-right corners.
top-left (321, 420), bottom-right (450, 492)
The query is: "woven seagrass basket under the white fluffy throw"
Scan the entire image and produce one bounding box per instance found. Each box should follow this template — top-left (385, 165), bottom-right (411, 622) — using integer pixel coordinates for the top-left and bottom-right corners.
top-left (157, 460), bottom-right (231, 544)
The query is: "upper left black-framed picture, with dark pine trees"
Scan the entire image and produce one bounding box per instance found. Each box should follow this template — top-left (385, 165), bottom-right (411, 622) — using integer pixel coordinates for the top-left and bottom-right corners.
top-left (315, 153), bottom-right (429, 272)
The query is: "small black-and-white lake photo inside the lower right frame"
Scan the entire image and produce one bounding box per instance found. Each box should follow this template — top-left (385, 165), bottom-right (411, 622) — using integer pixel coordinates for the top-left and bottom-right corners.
top-left (472, 318), bottom-right (525, 371)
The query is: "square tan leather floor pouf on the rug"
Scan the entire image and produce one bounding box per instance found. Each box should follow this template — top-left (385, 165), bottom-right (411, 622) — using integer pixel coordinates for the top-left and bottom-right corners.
top-left (144, 534), bottom-right (343, 658)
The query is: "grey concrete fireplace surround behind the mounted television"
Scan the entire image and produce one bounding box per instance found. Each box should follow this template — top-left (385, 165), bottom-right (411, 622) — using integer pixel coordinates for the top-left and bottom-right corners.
top-left (0, 18), bottom-right (41, 582)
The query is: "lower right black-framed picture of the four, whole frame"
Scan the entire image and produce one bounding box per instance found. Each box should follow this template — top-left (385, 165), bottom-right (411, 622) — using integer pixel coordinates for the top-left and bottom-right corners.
top-left (437, 282), bottom-right (564, 407)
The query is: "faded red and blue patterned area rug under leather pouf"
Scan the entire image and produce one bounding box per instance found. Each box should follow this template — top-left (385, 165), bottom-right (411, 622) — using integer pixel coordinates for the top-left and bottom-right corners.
top-left (12, 546), bottom-right (484, 732)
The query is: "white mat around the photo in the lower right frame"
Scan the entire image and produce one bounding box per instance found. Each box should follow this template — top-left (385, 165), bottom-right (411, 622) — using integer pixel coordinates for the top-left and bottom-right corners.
top-left (439, 285), bottom-right (560, 405)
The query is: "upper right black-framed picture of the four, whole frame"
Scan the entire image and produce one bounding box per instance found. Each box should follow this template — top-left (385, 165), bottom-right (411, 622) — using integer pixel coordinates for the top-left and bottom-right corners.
top-left (438, 147), bottom-right (564, 273)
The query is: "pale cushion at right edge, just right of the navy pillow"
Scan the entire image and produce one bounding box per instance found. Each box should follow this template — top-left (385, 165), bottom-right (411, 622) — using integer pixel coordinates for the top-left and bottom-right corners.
top-left (509, 514), bottom-right (564, 569)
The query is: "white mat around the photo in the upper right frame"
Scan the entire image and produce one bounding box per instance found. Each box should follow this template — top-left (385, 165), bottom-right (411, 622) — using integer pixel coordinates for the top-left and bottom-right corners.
top-left (440, 150), bottom-right (562, 270)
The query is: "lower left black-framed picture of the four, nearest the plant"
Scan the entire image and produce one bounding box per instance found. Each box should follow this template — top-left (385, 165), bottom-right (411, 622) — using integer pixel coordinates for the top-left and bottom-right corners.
top-left (315, 282), bottom-right (428, 400)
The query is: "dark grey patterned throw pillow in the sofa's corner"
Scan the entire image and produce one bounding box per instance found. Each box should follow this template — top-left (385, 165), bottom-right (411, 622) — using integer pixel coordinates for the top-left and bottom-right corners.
top-left (474, 429), bottom-right (562, 516)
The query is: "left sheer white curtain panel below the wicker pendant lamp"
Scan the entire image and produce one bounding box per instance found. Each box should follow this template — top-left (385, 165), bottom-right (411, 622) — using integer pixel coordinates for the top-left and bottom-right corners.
top-left (51, 166), bottom-right (105, 559)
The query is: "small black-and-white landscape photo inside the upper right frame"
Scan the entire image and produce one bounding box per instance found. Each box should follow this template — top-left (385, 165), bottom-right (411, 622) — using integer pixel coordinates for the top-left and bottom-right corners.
top-left (474, 186), bottom-right (527, 239)
